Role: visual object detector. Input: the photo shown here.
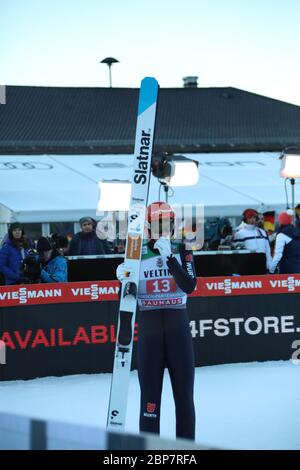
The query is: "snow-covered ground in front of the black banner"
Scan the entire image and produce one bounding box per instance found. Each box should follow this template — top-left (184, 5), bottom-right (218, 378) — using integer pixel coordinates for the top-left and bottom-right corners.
top-left (0, 361), bottom-right (300, 449)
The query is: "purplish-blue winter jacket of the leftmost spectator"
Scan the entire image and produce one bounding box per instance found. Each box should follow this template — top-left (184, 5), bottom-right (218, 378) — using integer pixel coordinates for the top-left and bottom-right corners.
top-left (0, 238), bottom-right (28, 285)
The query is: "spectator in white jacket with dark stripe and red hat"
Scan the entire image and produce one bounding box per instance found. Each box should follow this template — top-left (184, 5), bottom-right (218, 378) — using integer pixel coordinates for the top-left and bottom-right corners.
top-left (234, 209), bottom-right (272, 269)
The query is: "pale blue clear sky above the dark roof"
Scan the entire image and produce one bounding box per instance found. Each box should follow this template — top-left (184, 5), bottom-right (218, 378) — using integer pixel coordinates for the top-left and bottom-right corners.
top-left (0, 0), bottom-right (300, 105)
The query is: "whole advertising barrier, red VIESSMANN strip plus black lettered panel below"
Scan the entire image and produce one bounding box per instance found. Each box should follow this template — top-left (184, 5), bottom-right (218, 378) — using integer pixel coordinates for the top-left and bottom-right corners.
top-left (0, 275), bottom-right (300, 380)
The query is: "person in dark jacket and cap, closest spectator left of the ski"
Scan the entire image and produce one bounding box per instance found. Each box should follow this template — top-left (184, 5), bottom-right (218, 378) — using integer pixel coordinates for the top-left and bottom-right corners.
top-left (69, 217), bottom-right (111, 256)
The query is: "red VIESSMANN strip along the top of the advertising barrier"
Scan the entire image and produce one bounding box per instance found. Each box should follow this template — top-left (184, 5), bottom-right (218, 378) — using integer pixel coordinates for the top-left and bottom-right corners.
top-left (0, 274), bottom-right (300, 307)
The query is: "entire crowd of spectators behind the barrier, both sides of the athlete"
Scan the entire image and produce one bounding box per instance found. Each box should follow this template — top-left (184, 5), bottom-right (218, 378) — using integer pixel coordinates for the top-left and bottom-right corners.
top-left (0, 209), bottom-right (300, 285)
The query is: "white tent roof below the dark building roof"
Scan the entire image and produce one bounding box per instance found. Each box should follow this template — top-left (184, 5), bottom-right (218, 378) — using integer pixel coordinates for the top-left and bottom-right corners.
top-left (0, 152), bottom-right (300, 223)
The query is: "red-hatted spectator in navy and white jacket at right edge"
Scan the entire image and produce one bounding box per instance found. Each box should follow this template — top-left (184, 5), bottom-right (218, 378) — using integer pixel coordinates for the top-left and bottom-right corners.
top-left (270, 211), bottom-right (300, 274)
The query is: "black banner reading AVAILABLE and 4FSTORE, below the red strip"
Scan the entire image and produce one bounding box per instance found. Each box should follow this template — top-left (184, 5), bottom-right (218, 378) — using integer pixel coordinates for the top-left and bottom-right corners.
top-left (0, 288), bottom-right (300, 380)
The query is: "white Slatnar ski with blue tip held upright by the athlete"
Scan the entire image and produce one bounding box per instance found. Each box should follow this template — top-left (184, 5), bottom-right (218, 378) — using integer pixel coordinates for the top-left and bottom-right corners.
top-left (107, 77), bottom-right (158, 430)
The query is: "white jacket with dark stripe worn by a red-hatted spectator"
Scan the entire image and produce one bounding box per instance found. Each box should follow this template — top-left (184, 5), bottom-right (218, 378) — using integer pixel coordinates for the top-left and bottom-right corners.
top-left (234, 223), bottom-right (272, 269)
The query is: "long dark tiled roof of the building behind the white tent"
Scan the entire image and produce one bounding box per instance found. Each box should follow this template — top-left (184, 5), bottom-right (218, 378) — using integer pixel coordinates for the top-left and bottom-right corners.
top-left (0, 82), bottom-right (300, 154)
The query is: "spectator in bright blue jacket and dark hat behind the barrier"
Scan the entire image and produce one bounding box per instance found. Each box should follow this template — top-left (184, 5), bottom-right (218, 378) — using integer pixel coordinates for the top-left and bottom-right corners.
top-left (37, 237), bottom-right (68, 283)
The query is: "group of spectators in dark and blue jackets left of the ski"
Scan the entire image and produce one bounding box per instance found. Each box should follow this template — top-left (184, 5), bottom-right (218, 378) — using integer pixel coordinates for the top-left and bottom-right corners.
top-left (0, 217), bottom-right (113, 285)
